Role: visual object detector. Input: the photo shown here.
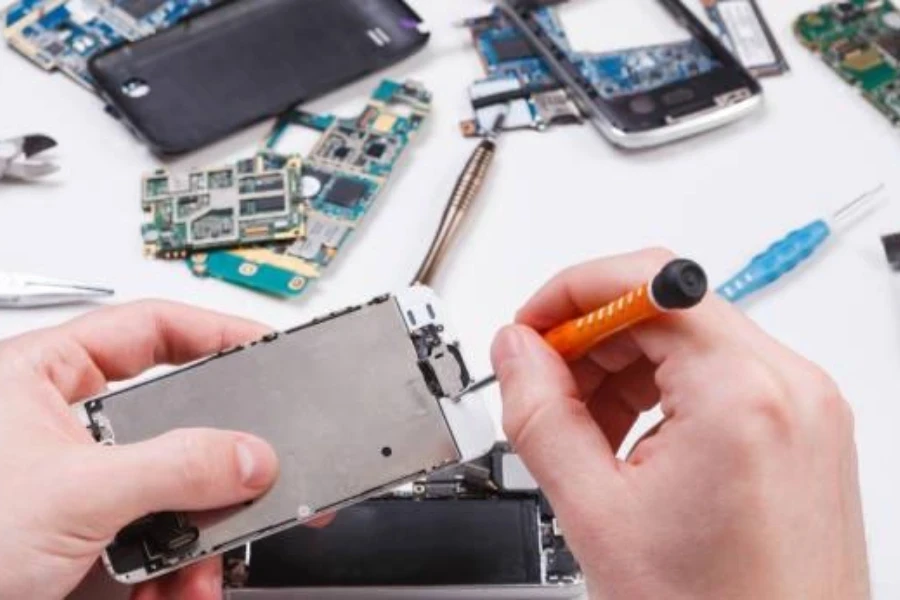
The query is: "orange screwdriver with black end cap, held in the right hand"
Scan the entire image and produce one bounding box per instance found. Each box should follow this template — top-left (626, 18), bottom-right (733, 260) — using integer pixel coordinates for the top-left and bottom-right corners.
top-left (454, 258), bottom-right (707, 400)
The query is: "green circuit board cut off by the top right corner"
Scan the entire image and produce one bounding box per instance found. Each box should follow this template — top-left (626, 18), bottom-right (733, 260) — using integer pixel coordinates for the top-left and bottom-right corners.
top-left (794, 0), bottom-right (900, 125)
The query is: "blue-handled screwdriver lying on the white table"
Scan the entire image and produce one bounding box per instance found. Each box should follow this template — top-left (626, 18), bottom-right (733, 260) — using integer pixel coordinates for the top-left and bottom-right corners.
top-left (716, 185), bottom-right (884, 302)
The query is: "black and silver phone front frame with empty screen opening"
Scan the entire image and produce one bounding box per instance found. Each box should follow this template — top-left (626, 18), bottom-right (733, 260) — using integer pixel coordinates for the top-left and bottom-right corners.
top-left (498, 0), bottom-right (762, 148)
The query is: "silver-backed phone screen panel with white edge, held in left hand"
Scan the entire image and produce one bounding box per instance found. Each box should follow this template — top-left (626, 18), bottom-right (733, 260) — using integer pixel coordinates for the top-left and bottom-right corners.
top-left (75, 286), bottom-right (495, 583)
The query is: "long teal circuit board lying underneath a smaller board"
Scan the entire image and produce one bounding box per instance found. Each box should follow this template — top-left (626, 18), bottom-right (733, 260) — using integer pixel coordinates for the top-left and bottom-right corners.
top-left (189, 80), bottom-right (431, 296)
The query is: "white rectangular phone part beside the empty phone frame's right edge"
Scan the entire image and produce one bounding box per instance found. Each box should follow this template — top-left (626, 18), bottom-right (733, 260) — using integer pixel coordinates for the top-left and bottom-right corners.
top-left (703, 0), bottom-right (789, 77)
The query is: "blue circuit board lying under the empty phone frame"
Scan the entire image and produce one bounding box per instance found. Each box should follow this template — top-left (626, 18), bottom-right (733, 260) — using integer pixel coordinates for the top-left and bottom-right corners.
top-left (461, 7), bottom-right (719, 136)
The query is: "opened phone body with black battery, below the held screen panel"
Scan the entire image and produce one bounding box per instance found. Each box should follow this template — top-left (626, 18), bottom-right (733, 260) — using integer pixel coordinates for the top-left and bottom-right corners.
top-left (225, 443), bottom-right (584, 600)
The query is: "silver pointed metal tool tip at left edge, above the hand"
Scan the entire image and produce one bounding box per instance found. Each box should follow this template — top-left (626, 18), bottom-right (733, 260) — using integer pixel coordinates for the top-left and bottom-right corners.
top-left (0, 272), bottom-right (114, 308)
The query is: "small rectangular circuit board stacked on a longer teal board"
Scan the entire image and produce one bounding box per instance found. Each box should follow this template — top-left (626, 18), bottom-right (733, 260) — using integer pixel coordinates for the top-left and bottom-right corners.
top-left (141, 154), bottom-right (303, 258)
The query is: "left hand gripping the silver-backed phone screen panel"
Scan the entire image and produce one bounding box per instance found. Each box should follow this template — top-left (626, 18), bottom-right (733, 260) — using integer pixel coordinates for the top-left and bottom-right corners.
top-left (0, 302), bottom-right (278, 600)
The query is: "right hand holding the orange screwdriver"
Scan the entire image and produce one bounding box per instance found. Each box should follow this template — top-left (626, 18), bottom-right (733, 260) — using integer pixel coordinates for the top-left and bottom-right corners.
top-left (492, 251), bottom-right (869, 600)
